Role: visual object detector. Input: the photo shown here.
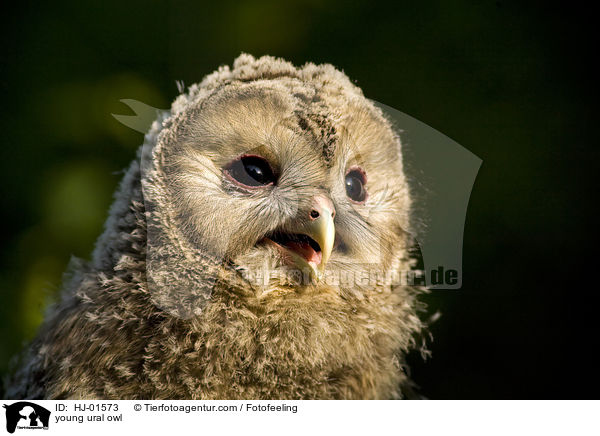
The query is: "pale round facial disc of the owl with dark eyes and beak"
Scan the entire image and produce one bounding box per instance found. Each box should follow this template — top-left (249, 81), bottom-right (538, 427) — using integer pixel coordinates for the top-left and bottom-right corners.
top-left (160, 79), bottom-right (410, 294)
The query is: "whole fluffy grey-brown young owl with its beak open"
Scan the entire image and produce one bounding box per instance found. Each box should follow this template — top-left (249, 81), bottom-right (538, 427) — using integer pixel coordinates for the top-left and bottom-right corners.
top-left (6, 55), bottom-right (424, 399)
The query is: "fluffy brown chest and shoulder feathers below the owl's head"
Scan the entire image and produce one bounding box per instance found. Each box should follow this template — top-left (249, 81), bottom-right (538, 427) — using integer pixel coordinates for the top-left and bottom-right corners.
top-left (25, 270), bottom-right (407, 399)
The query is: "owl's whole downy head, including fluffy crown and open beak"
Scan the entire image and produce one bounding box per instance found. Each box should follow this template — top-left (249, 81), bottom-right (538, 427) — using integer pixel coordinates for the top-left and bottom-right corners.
top-left (122, 55), bottom-right (410, 314)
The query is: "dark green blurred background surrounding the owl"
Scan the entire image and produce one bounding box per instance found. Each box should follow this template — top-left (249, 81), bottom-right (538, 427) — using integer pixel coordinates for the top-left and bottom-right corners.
top-left (0, 0), bottom-right (598, 398)
